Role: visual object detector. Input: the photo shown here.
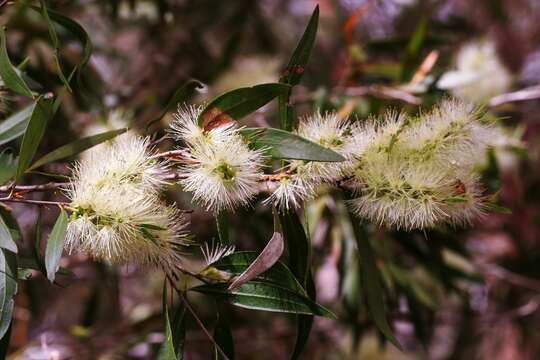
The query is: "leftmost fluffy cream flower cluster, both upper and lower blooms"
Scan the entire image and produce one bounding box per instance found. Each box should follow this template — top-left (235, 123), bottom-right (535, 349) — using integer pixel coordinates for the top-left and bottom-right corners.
top-left (66, 133), bottom-right (189, 274)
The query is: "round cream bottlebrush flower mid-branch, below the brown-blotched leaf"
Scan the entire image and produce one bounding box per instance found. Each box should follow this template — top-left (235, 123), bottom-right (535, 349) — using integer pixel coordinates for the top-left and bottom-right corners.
top-left (171, 107), bottom-right (264, 212)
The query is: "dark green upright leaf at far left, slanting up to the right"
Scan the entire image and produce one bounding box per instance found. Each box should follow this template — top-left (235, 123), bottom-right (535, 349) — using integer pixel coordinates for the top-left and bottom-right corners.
top-left (15, 97), bottom-right (52, 182)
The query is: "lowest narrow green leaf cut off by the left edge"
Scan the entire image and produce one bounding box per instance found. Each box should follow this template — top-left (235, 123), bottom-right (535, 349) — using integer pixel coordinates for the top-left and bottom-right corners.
top-left (0, 249), bottom-right (17, 338)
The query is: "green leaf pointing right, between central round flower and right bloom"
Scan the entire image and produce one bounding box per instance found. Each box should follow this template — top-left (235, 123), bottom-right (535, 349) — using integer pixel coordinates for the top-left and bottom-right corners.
top-left (239, 128), bottom-right (345, 162)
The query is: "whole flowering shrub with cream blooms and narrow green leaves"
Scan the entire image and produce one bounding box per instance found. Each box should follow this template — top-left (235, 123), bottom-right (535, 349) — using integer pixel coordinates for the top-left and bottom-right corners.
top-left (0, 2), bottom-right (520, 359)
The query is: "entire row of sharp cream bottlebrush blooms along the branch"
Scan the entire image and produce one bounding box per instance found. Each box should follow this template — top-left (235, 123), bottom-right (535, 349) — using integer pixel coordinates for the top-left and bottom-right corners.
top-left (66, 100), bottom-right (492, 268)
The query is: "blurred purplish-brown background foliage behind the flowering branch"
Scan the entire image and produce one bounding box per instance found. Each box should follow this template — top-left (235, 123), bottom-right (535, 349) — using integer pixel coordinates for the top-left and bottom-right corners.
top-left (0, 0), bottom-right (540, 359)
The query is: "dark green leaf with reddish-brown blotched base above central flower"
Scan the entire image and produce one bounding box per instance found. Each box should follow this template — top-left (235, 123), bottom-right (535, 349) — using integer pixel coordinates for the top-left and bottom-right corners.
top-left (198, 83), bottom-right (290, 130)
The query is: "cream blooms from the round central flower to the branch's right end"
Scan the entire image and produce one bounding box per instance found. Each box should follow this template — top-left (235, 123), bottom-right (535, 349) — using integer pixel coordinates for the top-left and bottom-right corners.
top-left (172, 100), bottom-right (491, 229)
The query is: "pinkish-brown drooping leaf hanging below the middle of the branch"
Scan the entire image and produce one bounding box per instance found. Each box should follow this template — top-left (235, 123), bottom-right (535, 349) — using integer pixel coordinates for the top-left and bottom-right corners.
top-left (229, 232), bottom-right (283, 291)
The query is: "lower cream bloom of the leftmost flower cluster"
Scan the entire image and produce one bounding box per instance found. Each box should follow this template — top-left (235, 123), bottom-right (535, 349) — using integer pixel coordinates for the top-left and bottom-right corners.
top-left (66, 188), bottom-right (188, 271)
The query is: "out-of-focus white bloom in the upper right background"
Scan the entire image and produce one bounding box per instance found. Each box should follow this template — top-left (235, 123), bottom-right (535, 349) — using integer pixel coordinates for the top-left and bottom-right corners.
top-left (437, 40), bottom-right (512, 103)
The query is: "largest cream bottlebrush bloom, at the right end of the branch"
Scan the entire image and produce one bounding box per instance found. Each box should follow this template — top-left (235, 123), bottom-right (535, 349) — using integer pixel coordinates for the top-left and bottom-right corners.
top-left (351, 100), bottom-right (491, 229)
